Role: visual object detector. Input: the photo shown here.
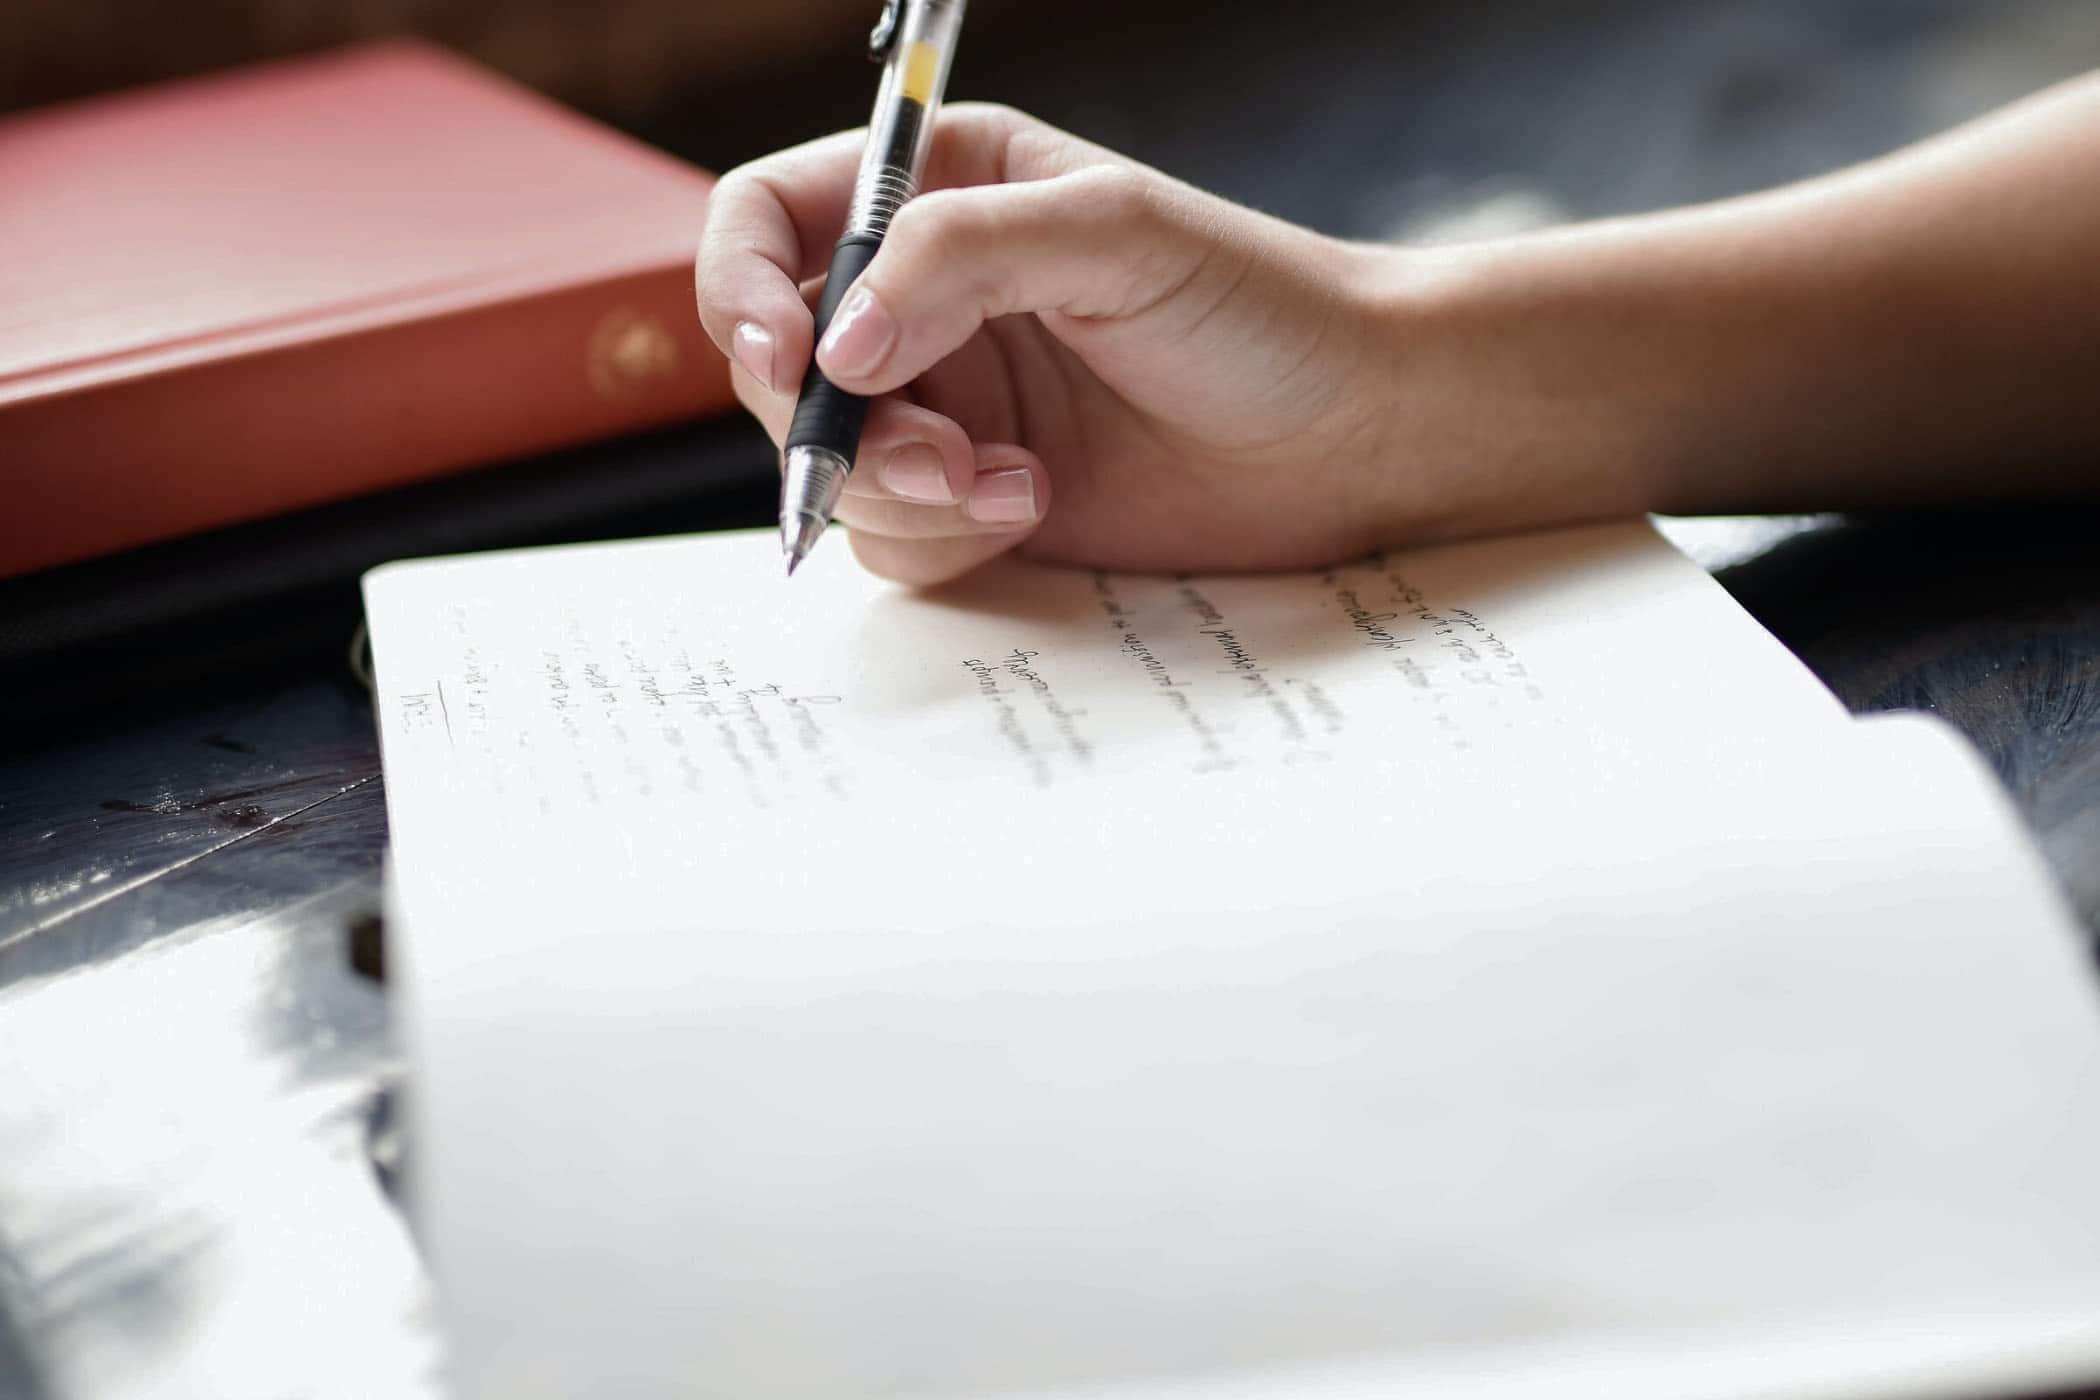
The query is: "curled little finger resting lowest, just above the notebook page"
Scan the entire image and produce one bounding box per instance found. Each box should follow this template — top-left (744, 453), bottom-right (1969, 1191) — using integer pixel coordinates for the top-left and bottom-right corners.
top-left (838, 443), bottom-right (1050, 588)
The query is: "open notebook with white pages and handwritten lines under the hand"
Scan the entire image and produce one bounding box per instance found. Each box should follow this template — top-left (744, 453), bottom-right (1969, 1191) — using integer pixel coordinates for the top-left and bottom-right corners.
top-left (365, 525), bottom-right (2100, 1400)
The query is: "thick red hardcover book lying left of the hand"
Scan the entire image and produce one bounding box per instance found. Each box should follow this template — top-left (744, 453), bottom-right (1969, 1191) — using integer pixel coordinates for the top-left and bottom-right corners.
top-left (0, 42), bottom-right (731, 577)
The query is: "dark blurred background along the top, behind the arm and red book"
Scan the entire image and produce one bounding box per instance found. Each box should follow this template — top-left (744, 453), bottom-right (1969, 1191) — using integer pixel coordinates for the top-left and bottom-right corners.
top-left (12, 0), bottom-right (2100, 237)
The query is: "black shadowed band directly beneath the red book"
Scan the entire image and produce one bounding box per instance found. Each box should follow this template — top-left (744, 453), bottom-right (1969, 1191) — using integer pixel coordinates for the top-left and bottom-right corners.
top-left (0, 418), bottom-right (779, 743)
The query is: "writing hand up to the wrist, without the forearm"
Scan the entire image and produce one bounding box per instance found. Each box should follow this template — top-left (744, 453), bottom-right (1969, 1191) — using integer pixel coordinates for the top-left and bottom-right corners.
top-left (697, 105), bottom-right (1422, 584)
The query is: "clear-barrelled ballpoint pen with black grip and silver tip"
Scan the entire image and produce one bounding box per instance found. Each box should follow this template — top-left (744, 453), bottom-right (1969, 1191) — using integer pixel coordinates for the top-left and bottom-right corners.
top-left (781, 0), bottom-right (964, 575)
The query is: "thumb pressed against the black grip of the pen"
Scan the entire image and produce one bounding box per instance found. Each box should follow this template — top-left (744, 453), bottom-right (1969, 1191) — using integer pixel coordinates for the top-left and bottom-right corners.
top-left (817, 166), bottom-right (1212, 395)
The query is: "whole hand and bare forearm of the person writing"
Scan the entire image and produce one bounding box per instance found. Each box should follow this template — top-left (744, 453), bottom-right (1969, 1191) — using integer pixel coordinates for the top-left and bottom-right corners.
top-left (697, 76), bottom-right (2100, 584)
